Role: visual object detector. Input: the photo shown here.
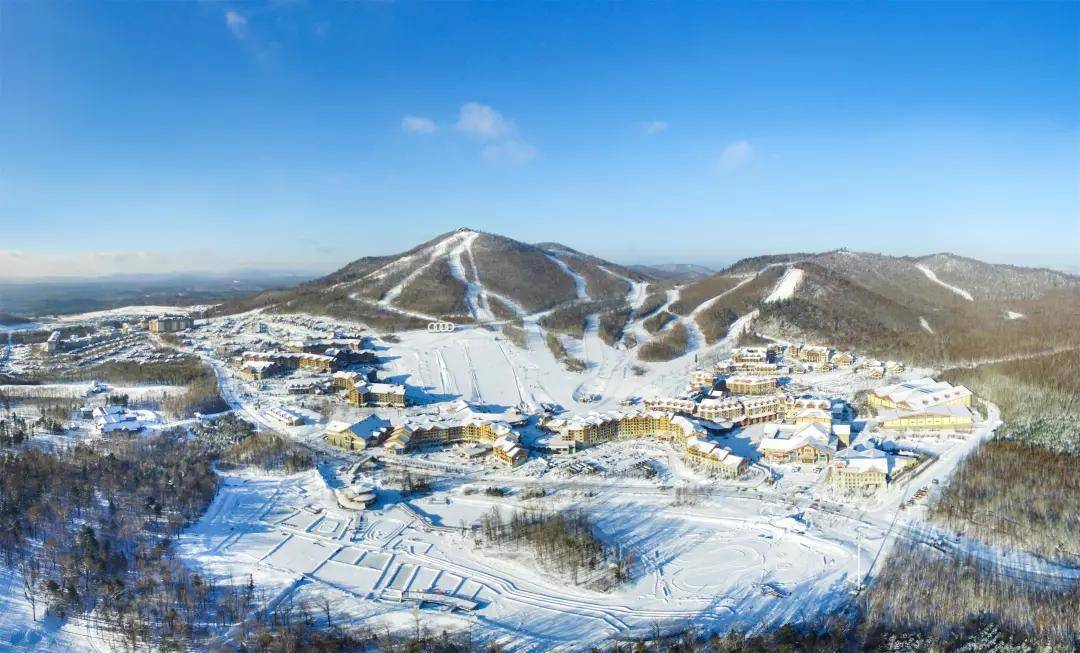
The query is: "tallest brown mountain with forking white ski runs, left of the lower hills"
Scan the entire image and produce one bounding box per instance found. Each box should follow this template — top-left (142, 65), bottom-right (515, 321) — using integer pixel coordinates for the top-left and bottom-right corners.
top-left (211, 229), bottom-right (646, 329)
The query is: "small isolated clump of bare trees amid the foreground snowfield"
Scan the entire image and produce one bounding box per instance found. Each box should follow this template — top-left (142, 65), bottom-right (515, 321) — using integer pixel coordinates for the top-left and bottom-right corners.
top-left (477, 508), bottom-right (633, 588)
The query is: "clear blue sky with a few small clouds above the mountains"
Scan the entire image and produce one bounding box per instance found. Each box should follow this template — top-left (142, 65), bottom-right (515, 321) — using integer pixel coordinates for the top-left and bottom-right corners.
top-left (0, 2), bottom-right (1080, 276)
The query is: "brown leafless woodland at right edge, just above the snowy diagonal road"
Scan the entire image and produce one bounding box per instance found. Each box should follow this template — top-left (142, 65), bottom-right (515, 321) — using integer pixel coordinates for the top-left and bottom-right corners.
top-left (930, 440), bottom-right (1080, 566)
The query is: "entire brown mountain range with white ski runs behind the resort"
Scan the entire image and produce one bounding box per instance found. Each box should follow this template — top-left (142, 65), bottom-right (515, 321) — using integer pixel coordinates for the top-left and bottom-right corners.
top-left (210, 229), bottom-right (1080, 360)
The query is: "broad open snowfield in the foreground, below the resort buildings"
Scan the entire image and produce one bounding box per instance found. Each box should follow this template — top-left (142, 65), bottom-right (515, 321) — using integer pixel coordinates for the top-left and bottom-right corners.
top-left (179, 470), bottom-right (868, 650)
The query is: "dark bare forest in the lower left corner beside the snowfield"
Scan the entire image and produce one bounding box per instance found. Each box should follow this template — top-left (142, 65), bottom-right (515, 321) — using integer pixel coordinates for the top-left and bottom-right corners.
top-left (0, 432), bottom-right (244, 645)
